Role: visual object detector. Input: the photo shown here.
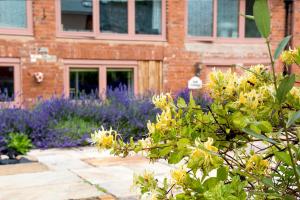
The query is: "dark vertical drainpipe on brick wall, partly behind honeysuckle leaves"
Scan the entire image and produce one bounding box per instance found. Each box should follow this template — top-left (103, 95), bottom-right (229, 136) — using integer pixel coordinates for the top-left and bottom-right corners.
top-left (283, 0), bottom-right (294, 75)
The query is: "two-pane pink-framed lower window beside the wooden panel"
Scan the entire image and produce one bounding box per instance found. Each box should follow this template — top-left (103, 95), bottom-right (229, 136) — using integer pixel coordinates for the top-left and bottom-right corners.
top-left (64, 60), bottom-right (137, 99)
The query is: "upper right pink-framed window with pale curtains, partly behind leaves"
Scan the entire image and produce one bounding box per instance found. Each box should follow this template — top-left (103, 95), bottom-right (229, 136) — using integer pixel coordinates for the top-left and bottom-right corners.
top-left (187, 0), bottom-right (260, 40)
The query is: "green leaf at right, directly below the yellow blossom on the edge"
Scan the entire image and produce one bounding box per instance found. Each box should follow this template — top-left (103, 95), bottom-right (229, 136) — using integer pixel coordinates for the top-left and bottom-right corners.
top-left (276, 74), bottom-right (296, 104)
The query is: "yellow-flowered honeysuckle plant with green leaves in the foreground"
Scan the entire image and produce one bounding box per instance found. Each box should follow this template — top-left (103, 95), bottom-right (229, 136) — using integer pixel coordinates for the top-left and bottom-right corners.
top-left (92, 0), bottom-right (300, 200)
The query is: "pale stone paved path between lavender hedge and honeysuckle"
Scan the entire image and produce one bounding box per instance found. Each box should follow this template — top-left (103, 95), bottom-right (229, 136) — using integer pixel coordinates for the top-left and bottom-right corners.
top-left (0, 147), bottom-right (171, 200)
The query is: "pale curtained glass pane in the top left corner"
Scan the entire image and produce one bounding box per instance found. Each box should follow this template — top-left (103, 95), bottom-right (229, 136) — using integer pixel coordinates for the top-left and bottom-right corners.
top-left (0, 0), bottom-right (27, 28)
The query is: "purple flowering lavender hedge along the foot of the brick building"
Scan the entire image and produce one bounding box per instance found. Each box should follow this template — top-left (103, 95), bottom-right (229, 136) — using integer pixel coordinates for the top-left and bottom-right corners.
top-left (0, 87), bottom-right (211, 154)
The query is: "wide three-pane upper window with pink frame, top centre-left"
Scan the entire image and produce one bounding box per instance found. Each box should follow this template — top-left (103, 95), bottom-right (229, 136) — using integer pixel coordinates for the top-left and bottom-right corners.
top-left (57, 0), bottom-right (166, 40)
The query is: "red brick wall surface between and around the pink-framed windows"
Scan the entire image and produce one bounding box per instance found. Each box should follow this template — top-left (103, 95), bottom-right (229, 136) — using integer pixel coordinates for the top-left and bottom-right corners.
top-left (0, 0), bottom-right (300, 104)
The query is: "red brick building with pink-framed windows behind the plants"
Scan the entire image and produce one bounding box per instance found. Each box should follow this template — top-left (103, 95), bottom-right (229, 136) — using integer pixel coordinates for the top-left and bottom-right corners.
top-left (0, 0), bottom-right (300, 106)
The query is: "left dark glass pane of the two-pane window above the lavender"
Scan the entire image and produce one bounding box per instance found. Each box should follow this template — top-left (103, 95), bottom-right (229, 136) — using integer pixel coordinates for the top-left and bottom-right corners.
top-left (70, 69), bottom-right (99, 98)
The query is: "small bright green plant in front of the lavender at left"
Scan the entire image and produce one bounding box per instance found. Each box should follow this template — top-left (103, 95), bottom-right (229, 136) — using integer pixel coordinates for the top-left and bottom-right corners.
top-left (7, 133), bottom-right (33, 157)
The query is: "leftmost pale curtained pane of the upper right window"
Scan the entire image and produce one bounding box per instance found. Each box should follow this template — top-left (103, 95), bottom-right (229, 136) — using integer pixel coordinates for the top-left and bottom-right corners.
top-left (188, 0), bottom-right (213, 36)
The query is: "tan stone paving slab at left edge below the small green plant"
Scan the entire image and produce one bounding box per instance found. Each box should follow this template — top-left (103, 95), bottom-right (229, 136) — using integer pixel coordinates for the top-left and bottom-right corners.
top-left (0, 162), bottom-right (48, 176)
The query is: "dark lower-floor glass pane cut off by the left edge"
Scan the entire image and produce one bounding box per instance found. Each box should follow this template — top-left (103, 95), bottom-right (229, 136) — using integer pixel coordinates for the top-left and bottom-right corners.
top-left (0, 67), bottom-right (14, 101)
